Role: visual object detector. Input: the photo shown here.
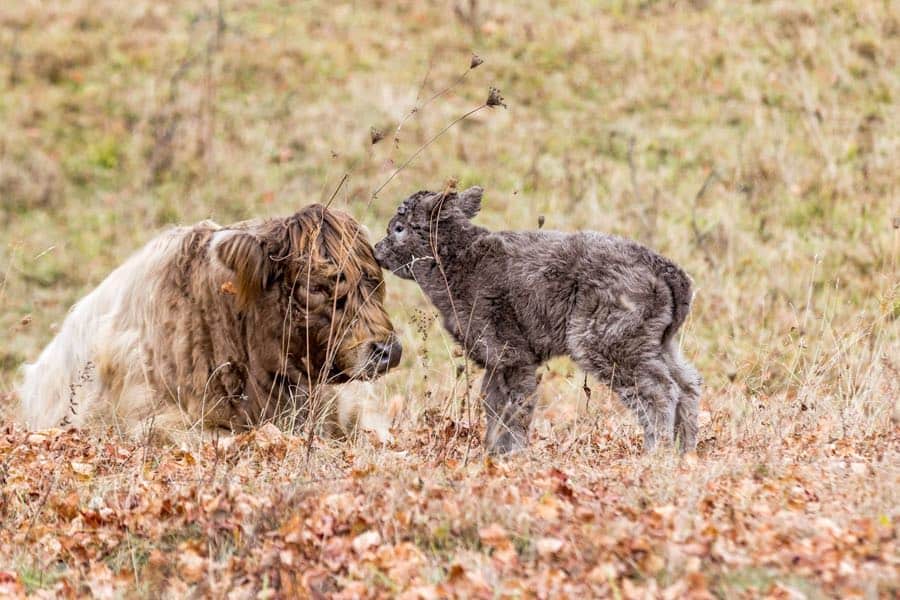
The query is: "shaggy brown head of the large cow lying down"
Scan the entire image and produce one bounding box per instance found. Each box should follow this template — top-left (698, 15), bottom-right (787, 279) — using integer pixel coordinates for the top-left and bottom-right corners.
top-left (211, 205), bottom-right (402, 385)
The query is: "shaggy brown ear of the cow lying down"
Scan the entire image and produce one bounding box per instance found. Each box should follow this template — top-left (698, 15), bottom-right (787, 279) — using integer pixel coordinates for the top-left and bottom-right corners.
top-left (212, 231), bottom-right (270, 310)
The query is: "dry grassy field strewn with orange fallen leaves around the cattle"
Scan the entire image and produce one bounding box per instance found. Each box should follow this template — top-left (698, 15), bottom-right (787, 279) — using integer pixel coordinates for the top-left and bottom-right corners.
top-left (0, 0), bottom-right (900, 598)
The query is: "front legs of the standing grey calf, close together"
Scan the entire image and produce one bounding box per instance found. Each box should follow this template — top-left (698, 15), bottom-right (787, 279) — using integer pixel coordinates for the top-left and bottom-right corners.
top-left (481, 365), bottom-right (537, 454)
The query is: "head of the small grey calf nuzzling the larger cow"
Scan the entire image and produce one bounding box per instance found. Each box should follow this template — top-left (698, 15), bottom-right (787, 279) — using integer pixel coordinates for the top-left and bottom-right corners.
top-left (375, 186), bottom-right (484, 279)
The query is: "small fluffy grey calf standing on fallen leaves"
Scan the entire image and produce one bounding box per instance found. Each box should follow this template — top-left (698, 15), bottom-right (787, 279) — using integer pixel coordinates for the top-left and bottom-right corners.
top-left (375, 187), bottom-right (701, 453)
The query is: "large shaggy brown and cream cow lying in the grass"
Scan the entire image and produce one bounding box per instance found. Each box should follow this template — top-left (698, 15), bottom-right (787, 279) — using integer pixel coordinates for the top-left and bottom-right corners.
top-left (19, 205), bottom-right (401, 440)
